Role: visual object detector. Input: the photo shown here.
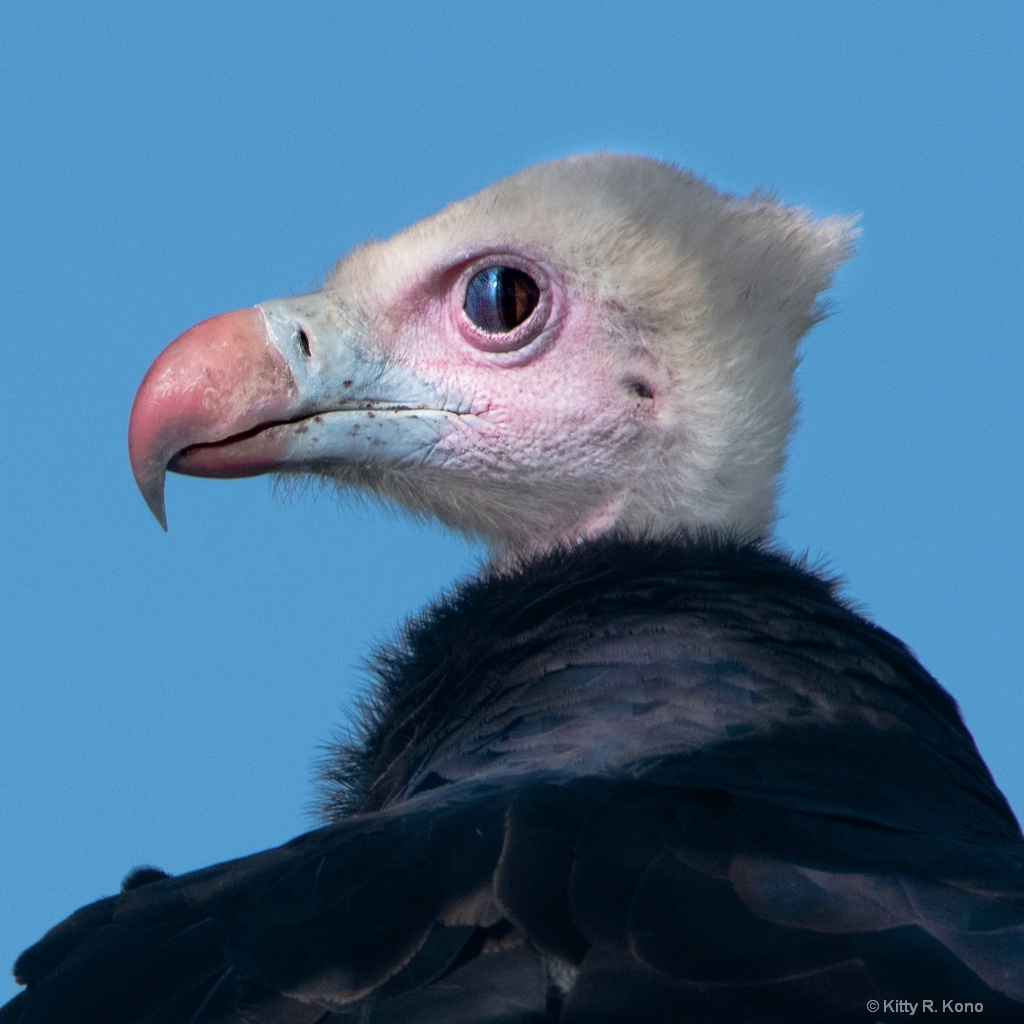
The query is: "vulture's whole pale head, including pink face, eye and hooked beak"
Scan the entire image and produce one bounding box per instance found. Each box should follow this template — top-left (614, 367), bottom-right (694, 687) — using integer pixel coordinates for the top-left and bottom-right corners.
top-left (129, 154), bottom-right (853, 556)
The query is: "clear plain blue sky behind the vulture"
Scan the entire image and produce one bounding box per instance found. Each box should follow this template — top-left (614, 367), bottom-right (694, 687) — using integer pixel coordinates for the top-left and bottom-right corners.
top-left (0, 0), bottom-right (1024, 999)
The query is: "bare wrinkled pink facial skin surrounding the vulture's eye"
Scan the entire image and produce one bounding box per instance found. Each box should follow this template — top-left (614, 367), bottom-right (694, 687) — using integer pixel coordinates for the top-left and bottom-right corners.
top-left (371, 241), bottom-right (655, 493)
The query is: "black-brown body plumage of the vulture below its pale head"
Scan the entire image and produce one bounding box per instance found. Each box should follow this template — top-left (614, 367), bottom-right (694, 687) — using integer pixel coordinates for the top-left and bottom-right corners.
top-left (6, 538), bottom-right (1024, 1024)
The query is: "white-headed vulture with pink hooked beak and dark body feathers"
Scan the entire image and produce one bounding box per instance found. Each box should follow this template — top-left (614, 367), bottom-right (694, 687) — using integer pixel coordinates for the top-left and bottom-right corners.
top-left (0, 154), bottom-right (1024, 1024)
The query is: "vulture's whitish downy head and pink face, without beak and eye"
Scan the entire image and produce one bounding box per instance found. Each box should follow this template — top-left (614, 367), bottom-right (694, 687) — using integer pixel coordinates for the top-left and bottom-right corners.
top-left (315, 154), bottom-right (855, 553)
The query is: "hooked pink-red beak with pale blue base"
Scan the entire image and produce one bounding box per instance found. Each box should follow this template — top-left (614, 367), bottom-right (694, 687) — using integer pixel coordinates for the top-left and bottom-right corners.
top-left (128, 292), bottom-right (456, 529)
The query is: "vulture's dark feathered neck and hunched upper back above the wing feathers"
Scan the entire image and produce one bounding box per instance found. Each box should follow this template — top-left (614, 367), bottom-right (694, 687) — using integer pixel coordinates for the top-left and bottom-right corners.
top-left (315, 535), bottom-right (1016, 831)
